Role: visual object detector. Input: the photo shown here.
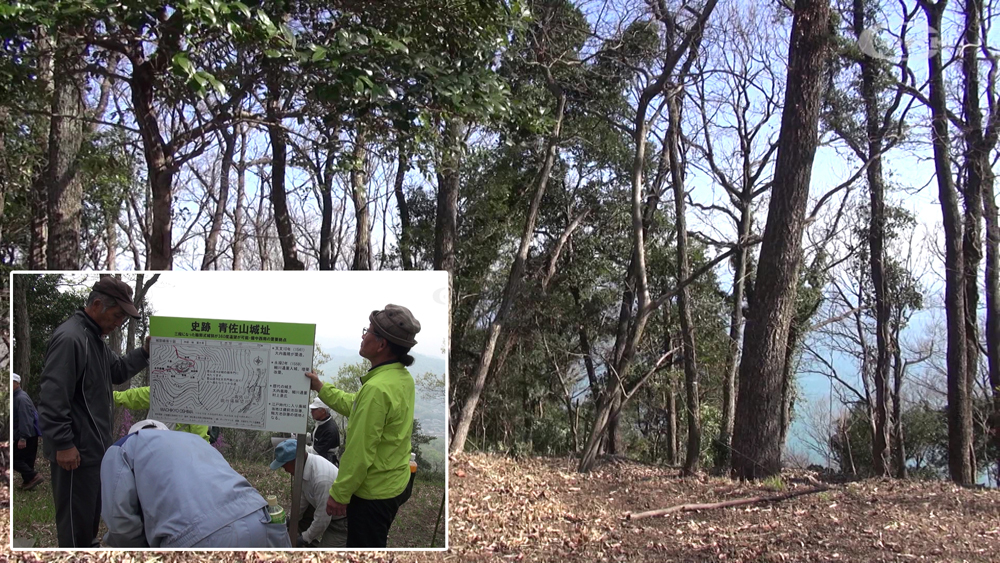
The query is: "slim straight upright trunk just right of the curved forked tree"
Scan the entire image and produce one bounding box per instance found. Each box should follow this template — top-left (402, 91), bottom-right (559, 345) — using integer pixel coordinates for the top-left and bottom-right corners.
top-left (667, 91), bottom-right (701, 475)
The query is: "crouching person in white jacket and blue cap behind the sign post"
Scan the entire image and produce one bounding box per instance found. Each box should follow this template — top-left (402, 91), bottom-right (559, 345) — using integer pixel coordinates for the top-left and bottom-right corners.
top-left (271, 439), bottom-right (347, 547)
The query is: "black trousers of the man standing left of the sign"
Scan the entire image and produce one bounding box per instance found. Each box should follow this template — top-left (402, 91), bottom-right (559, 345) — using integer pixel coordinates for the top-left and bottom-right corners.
top-left (51, 461), bottom-right (101, 547)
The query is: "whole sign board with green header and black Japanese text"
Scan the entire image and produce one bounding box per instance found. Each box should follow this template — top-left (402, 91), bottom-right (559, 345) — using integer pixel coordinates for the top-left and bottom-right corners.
top-left (149, 317), bottom-right (316, 433)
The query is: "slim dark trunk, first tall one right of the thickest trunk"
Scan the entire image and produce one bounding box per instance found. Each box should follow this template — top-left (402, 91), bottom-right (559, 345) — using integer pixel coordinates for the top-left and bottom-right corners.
top-left (853, 0), bottom-right (892, 475)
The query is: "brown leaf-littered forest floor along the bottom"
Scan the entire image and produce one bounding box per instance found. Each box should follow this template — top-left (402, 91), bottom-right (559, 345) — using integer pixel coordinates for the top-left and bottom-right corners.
top-left (0, 454), bottom-right (1000, 563)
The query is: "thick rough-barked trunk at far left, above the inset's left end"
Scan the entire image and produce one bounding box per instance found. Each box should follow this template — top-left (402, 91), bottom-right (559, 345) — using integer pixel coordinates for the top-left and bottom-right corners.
top-left (45, 36), bottom-right (85, 270)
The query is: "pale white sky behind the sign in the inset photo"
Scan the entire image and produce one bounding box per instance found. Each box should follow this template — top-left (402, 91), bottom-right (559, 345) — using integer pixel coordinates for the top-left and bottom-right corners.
top-left (51, 271), bottom-right (448, 358)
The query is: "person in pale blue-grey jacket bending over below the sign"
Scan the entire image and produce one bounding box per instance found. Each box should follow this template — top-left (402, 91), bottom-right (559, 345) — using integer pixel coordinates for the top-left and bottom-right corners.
top-left (101, 420), bottom-right (291, 548)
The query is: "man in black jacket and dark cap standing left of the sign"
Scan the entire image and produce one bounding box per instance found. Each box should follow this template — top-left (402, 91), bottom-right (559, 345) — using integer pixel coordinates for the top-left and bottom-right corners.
top-left (38, 277), bottom-right (149, 547)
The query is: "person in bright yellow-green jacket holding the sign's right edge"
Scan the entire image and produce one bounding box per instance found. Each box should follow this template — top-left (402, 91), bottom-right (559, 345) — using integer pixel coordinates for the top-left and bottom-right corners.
top-left (306, 304), bottom-right (420, 547)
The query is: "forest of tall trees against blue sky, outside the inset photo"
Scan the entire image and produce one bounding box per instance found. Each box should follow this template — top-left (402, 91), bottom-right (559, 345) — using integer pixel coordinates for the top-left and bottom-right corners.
top-left (0, 0), bottom-right (1000, 486)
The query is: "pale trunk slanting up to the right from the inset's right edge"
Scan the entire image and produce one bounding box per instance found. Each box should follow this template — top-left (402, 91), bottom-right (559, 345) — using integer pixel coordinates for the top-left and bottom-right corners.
top-left (450, 91), bottom-right (566, 453)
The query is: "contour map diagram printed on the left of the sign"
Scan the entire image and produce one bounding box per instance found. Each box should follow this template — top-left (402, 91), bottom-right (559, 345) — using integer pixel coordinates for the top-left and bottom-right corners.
top-left (150, 339), bottom-right (271, 429)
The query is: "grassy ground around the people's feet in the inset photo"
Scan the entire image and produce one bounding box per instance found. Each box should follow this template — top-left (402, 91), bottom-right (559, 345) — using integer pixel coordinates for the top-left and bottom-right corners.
top-left (11, 452), bottom-right (445, 548)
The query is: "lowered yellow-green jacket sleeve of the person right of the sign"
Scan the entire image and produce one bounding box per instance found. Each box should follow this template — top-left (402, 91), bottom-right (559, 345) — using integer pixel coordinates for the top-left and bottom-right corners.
top-left (332, 386), bottom-right (389, 504)
